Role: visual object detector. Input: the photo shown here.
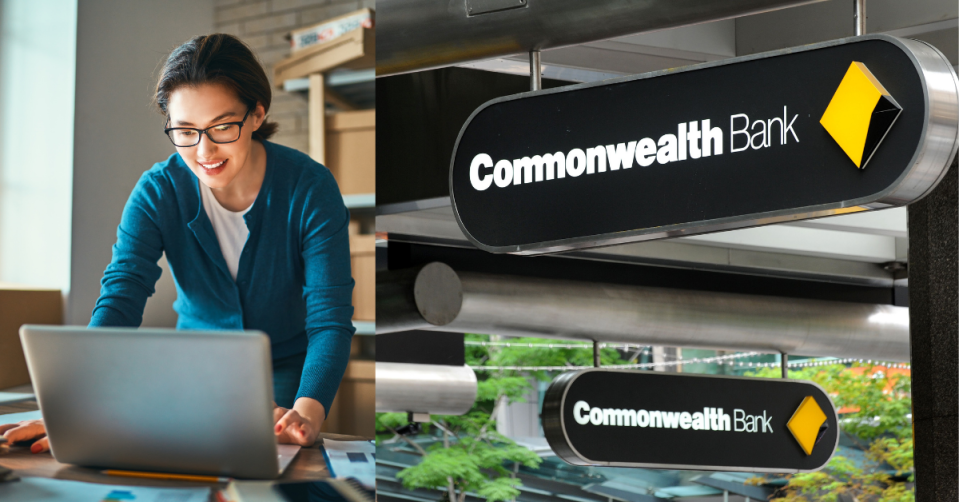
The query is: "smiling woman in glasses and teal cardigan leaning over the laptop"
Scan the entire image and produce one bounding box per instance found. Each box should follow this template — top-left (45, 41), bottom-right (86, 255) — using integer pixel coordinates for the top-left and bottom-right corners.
top-left (0, 34), bottom-right (354, 453)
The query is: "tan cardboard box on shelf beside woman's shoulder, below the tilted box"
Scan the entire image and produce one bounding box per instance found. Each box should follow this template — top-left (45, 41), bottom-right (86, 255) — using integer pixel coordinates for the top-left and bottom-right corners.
top-left (328, 110), bottom-right (376, 194)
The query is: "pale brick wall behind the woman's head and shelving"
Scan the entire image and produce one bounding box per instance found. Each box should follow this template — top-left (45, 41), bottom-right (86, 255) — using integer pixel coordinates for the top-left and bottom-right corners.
top-left (213, 0), bottom-right (376, 153)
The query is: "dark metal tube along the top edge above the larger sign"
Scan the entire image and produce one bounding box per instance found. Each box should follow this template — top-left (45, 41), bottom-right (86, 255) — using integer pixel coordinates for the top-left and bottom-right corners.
top-left (376, 0), bottom-right (820, 77)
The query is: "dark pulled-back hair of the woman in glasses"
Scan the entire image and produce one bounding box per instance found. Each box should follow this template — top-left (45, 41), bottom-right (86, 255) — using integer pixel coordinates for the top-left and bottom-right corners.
top-left (154, 33), bottom-right (277, 141)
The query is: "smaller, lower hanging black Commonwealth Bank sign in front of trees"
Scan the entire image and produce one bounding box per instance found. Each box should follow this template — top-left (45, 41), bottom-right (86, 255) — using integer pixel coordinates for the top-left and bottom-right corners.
top-left (542, 369), bottom-right (839, 472)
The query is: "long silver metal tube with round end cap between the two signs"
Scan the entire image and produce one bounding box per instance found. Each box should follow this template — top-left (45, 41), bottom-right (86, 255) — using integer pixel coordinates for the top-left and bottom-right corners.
top-left (377, 263), bottom-right (909, 361)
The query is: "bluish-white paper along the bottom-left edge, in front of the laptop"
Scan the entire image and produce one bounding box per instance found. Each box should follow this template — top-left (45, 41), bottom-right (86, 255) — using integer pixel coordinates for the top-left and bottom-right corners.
top-left (0, 478), bottom-right (210, 502)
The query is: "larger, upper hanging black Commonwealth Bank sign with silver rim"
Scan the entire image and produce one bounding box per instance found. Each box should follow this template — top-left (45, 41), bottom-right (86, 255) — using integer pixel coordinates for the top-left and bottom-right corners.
top-left (450, 35), bottom-right (959, 254)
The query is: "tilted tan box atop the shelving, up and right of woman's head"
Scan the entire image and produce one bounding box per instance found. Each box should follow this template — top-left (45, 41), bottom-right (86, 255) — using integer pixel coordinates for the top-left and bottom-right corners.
top-left (273, 28), bottom-right (376, 89)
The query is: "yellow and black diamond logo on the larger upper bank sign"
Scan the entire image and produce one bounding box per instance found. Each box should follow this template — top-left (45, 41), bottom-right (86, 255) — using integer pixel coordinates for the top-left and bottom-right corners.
top-left (819, 61), bottom-right (902, 169)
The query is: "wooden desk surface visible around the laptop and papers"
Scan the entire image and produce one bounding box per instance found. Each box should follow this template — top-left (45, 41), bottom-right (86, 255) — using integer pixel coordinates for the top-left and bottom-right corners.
top-left (0, 401), bottom-right (363, 488)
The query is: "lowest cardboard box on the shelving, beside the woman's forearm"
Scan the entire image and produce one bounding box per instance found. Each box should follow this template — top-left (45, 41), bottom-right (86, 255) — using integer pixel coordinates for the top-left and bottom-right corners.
top-left (322, 359), bottom-right (376, 439)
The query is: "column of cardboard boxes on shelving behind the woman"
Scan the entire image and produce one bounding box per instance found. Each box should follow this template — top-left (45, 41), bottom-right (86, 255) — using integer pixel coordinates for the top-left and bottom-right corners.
top-left (274, 9), bottom-right (376, 437)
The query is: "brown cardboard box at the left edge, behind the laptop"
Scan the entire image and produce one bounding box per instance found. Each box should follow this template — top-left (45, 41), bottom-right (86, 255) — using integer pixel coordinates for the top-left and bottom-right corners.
top-left (0, 284), bottom-right (63, 389)
